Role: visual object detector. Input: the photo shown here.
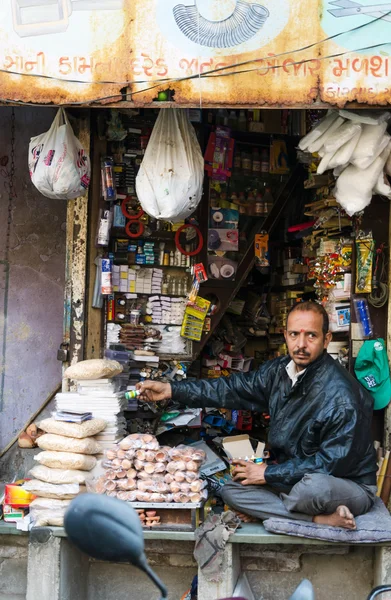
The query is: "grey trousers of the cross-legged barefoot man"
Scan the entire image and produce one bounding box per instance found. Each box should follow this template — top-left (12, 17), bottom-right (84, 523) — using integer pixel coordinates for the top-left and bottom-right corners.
top-left (221, 473), bottom-right (376, 521)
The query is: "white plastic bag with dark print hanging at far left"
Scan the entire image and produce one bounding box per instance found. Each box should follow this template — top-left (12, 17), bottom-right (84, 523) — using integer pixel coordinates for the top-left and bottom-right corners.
top-left (28, 108), bottom-right (91, 200)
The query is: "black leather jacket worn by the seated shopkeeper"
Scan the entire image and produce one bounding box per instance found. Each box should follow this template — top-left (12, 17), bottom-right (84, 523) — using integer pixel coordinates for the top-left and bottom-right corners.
top-left (172, 352), bottom-right (377, 486)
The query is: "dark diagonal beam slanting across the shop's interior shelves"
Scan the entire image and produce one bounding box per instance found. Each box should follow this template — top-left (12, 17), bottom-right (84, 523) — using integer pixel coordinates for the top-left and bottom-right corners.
top-left (193, 164), bottom-right (305, 358)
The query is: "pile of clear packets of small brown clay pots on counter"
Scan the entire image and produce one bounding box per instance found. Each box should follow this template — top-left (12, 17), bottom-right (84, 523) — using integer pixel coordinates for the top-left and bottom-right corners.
top-left (94, 434), bottom-right (207, 504)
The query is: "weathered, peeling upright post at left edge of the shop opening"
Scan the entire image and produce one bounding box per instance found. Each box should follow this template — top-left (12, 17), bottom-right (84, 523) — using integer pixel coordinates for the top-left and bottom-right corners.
top-left (62, 111), bottom-right (90, 391)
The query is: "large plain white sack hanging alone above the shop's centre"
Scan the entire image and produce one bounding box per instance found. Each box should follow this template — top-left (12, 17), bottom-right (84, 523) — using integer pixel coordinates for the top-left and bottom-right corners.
top-left (136, 108), bottom-right (204, 222)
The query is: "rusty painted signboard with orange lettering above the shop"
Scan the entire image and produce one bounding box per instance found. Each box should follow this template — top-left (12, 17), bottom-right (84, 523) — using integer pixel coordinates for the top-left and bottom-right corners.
top-left (0, 0), bottom-right (391, 107)
